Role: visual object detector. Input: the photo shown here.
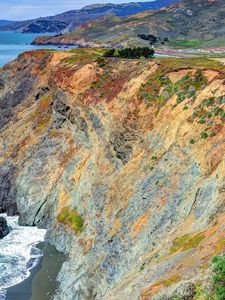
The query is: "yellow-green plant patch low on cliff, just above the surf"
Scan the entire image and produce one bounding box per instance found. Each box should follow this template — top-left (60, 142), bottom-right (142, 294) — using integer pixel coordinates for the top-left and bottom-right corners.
top-left (57, 206), bottom-right (84, 234)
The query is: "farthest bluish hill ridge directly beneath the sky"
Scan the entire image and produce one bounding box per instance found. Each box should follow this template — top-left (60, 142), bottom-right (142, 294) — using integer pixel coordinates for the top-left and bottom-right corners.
top-left (0, 0), bottom-right (177, 33)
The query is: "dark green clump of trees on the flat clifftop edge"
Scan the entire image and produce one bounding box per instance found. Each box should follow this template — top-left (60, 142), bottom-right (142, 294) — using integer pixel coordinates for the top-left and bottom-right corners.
top-left (103, 47), bottom-right (155, 59)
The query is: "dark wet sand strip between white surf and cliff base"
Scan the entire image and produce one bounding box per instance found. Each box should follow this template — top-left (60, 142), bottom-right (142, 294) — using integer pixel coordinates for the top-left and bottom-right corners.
top-left (6, 243), bottom-right (66, 300)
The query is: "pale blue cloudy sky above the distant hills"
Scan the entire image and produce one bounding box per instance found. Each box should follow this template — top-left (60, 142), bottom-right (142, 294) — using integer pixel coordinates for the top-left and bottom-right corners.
top-left (0, 0), bottom-right (152, 20)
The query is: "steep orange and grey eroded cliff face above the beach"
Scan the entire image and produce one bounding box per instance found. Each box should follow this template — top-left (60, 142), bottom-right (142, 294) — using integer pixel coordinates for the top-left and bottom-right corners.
top-left (0, 49), bottom-right (225, 300)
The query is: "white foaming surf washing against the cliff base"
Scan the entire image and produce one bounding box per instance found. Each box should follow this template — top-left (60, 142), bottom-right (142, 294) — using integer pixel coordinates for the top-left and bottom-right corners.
top-left (0, 215), bottom-right (46, 300)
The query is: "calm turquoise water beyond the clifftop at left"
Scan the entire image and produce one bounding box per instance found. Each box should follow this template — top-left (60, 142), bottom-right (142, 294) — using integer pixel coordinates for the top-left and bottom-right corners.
top-left (0, 31), bottom-right (58, 67)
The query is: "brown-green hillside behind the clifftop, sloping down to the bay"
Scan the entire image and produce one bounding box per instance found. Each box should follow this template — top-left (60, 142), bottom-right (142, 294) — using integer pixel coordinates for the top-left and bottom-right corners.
top-left (32, 0), bottom-right (225, 48)
